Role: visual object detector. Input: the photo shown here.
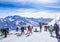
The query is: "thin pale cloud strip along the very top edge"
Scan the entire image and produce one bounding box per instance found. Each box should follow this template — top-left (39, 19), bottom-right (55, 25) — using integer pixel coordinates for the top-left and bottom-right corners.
top-left (0, 0), bottom-right (58, 3)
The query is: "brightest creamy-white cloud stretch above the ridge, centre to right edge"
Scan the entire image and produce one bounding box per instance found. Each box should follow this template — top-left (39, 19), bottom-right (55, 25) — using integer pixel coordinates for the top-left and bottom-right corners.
top-left (17, 11), bottom-right (60, 18)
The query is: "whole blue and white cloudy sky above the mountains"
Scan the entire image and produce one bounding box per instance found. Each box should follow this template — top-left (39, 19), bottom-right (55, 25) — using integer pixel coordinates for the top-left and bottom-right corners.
top-left (0, 0), bottom-right (60, 18)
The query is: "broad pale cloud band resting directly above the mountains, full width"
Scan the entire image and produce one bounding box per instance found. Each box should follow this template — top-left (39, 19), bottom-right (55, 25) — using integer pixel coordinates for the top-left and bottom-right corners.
top-left (0, 9), bottom-right (60, 18)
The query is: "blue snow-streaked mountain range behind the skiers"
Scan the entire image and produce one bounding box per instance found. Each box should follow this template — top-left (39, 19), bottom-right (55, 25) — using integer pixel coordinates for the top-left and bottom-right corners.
top-left (0, 15), bottom-right (52, 29)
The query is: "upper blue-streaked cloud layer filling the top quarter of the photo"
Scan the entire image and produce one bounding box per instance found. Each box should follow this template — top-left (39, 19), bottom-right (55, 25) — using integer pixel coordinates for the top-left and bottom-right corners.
top-left (0, 0), bottom-right (60, 11)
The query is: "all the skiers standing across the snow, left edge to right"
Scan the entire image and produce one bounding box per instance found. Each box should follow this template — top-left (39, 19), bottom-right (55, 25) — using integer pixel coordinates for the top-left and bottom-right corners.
top-left (1, 23), bottom-right (60, 38)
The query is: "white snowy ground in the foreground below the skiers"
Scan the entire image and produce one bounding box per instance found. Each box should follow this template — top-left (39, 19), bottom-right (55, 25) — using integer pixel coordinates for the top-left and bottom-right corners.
top-left (0, 27), bottom-right (60, 42)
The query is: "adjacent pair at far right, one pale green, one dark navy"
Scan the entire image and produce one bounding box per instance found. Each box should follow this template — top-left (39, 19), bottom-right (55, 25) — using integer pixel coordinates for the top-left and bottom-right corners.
top-left (49, 23), bottom-right (60, 38)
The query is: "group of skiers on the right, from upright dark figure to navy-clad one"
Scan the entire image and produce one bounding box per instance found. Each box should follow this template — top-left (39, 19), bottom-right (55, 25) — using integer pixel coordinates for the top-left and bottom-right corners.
top-left (39, 22), bottom-right (60, 38)
